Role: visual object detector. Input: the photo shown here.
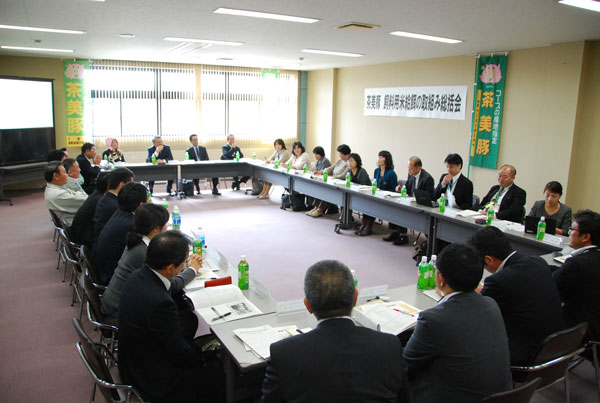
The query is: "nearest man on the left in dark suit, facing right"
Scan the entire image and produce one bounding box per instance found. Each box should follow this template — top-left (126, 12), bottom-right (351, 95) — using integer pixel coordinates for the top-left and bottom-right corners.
top-left (119, 231), bottom-right (224, 403)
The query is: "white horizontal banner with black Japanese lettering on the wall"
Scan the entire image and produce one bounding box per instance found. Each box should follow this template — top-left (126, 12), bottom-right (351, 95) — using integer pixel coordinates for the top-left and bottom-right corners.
top-left (364, 85), bottom-right (467, 120)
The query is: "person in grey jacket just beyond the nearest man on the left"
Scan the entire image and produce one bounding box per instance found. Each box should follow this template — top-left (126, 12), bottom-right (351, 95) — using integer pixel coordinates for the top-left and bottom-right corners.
top-left (102, 203), bottom-right (202, 318)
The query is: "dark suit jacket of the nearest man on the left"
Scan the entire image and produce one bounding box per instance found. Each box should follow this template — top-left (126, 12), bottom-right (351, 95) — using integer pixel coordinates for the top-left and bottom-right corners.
top-left (119, 266), bottom-right (210, 402)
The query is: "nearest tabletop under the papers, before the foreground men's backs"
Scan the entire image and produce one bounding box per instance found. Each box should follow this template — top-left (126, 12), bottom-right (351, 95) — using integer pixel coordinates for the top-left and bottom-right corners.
top-left (211, 284), bottom-right (437, 403)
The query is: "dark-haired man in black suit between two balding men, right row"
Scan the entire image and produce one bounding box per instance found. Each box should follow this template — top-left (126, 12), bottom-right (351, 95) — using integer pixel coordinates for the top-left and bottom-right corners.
top-left (433, 154), bottom-right (473, 210)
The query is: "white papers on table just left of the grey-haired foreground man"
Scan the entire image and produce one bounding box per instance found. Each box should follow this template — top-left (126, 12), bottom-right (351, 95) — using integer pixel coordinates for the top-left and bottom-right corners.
top-left (233, 325), bottom-right (311, 360)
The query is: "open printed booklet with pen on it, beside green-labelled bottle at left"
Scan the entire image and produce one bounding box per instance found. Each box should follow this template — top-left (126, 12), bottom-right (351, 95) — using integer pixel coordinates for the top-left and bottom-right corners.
top-left (186, 284), bottom-right (262, 324)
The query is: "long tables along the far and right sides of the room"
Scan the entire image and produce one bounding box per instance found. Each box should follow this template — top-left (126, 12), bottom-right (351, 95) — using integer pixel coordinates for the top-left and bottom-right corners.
top-left (124, 158), bottom-right (567, 256)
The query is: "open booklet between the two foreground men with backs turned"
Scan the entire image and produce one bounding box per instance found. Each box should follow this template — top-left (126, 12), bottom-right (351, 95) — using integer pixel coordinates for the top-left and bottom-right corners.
top-left (352, 300), bottom-right (420, 335)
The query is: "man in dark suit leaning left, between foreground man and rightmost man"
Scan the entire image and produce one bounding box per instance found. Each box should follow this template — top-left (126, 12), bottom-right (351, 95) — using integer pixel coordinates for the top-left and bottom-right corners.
top-left (469, 227), bottom-right (563, 365)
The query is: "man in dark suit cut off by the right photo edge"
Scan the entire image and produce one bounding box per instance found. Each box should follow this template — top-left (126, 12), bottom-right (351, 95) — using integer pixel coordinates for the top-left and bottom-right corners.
top-left (553, 210), bottom-right (600, 341)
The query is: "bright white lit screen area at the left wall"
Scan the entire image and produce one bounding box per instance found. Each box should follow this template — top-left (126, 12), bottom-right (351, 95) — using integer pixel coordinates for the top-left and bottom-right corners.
top-left (0, 77), bottom-right (54, 130)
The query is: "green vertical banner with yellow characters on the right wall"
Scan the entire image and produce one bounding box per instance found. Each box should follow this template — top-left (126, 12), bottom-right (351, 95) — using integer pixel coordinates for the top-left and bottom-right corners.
top-left (469, 55), bottom-right (507, 169)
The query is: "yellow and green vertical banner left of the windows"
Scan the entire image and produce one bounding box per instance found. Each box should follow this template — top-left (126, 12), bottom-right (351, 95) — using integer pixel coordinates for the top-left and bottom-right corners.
top-left (63, 60), bottom-right (90, 147)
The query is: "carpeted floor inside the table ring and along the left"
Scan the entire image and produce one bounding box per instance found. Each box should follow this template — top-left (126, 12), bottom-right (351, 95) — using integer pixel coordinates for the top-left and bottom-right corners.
top-left (0, 185), bottom-right (598, 403)
